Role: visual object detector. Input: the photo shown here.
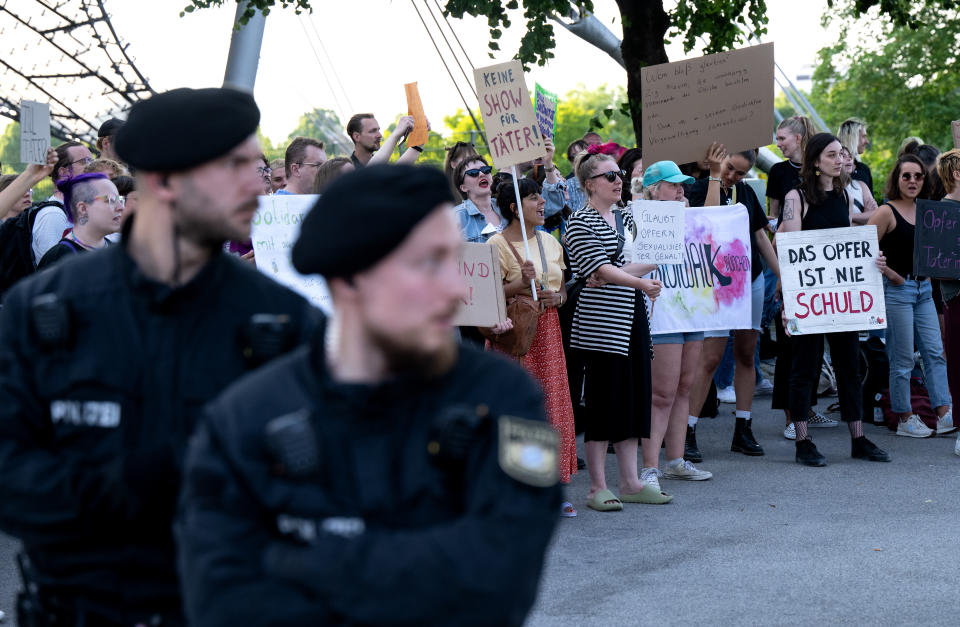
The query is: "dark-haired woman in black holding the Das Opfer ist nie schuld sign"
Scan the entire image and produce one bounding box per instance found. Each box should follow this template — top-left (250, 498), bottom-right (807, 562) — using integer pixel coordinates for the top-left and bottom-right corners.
top-left (779, 133), bottom-right (890, 466)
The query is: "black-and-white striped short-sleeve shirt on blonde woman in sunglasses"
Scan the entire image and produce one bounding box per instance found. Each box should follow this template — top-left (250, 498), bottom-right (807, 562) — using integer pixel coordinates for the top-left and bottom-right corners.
top-left (566, 206), bottom-right (642, 356)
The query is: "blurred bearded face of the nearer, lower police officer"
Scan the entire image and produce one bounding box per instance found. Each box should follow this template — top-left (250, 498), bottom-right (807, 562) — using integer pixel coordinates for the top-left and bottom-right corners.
top-left (354, 204), bottom-right (467, 372)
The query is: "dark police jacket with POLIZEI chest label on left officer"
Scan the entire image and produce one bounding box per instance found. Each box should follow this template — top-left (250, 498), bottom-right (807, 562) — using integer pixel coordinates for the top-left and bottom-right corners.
top-left (0, 234), bottom-right (319, 612)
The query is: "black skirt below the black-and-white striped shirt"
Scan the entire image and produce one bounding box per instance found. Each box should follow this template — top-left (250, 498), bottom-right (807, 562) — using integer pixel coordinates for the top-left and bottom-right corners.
top-left (580, 291), bottom-right (652, 442)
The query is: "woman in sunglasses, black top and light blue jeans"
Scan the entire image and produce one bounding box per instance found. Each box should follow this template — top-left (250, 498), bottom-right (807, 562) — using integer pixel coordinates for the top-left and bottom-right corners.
top-left (868, 154), bottom-right (956, 438)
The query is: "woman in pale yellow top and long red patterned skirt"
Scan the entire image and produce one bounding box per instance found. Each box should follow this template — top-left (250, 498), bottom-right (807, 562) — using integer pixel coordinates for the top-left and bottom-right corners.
top-left (496, 178), bottom-right (577, 517)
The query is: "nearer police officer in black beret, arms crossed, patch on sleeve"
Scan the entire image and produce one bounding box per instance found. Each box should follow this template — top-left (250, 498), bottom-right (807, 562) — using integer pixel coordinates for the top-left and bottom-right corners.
top-left (176, 165), bottom-right (561, 627)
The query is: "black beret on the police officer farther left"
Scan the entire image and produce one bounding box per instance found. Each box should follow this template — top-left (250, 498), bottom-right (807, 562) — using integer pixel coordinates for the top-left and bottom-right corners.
top-left (115, 87), bottom-right (260, 172)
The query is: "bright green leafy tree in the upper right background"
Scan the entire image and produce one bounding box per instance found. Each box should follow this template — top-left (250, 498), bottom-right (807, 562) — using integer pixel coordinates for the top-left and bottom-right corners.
top-left (811, 0), bottom-right (960, 193)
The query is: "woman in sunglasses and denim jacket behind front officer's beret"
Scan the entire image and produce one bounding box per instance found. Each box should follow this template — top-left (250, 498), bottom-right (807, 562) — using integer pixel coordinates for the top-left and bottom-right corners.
top-left (453, 155), bottom-right (506, 244)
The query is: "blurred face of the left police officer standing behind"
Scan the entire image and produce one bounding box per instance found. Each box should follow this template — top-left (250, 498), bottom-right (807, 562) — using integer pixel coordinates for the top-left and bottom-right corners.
top-left (170, 135), bottom-right (264, 245)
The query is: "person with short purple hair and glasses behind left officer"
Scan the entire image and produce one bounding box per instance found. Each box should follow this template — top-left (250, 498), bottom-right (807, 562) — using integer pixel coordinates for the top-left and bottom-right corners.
top-left (37, 172), bottom-right (123, 270)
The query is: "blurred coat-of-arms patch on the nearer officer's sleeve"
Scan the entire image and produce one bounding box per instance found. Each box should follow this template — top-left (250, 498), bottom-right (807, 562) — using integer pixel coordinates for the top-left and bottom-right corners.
top-left (498, 416), bottom-right (560, 488)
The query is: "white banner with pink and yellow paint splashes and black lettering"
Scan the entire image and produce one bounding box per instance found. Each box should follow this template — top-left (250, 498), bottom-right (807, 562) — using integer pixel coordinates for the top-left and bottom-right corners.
top-left (637, 203), bottom-right (752, 333)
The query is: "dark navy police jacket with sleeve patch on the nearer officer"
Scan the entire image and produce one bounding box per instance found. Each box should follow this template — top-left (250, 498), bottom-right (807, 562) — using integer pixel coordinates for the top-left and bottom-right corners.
top-left (177, 324), bottom-right (560, 626)
